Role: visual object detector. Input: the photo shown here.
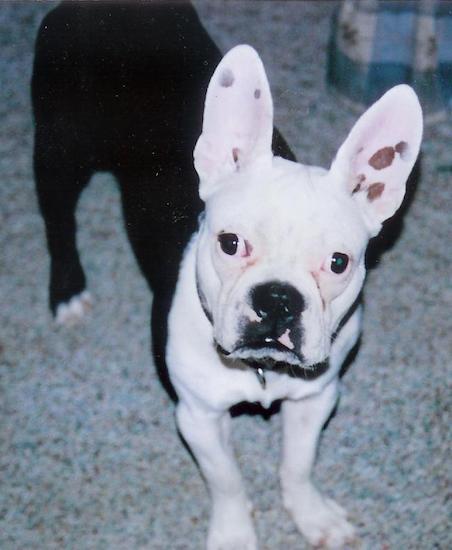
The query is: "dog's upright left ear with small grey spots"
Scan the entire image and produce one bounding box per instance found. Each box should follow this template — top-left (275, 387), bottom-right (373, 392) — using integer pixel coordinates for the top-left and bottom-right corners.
top-left (194, 45), bottom-right (273, 200)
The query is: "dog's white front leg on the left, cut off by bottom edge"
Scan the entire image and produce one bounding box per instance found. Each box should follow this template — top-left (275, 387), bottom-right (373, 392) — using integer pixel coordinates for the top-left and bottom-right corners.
top-left (176, 402), bottom-right (257, 550)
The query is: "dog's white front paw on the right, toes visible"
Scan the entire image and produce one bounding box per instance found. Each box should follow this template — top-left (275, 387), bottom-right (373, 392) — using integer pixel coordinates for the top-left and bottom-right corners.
top-left (284, 483), bottom-right (355, 549)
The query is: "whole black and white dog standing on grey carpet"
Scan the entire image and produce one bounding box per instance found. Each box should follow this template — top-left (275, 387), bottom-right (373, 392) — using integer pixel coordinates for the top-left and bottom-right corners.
top-left (32, 2), bottom-right (422, 550)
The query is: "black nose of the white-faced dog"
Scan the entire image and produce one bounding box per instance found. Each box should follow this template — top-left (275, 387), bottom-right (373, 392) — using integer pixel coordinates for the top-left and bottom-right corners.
top-left (251, 281), bottom-right (304, 336)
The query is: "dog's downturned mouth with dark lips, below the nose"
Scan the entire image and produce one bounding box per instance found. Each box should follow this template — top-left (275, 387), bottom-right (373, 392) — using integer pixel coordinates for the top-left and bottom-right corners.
top-left (217, 339), bottom-right (329, 380)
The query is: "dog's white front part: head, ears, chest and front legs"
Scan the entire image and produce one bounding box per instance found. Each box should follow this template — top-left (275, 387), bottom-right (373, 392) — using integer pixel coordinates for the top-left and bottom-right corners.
top-left (167, 46), bottom-right (422, 550)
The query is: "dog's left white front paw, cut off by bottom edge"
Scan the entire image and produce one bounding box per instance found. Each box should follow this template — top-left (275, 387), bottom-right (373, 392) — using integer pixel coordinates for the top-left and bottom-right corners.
top-left (207, 502), bottom-right (257, 550)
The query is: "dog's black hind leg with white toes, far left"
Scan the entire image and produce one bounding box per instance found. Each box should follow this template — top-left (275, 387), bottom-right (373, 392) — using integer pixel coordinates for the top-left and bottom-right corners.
top-left (34, 130), bottom-right (92, 325)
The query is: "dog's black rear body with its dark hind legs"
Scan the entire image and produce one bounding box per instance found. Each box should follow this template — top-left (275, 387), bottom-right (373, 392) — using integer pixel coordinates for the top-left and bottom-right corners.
top-left (32, 2), bottom-right (220, 312)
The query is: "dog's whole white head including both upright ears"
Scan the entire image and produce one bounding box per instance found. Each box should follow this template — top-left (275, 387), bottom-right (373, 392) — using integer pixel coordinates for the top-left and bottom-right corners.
top-left (194, 46), bottom-right (422, 376)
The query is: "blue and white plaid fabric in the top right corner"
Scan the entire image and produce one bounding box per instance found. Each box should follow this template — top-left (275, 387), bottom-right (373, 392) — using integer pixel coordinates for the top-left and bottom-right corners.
top-left (327, 0), bottom-right (452, 116)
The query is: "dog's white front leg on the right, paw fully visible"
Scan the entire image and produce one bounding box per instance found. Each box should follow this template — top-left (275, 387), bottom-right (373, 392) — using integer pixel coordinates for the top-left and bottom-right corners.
top-left (280, 381), bottom-right (354, 548)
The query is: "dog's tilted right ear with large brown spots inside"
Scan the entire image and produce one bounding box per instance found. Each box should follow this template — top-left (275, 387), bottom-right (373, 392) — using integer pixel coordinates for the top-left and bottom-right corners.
top-left (330, 84), bottom-right (422, 235)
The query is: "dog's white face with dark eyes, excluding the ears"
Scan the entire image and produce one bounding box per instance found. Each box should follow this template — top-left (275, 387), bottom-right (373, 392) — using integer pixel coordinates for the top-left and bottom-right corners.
top-left (198, 163), bottom-right (369, 365)
